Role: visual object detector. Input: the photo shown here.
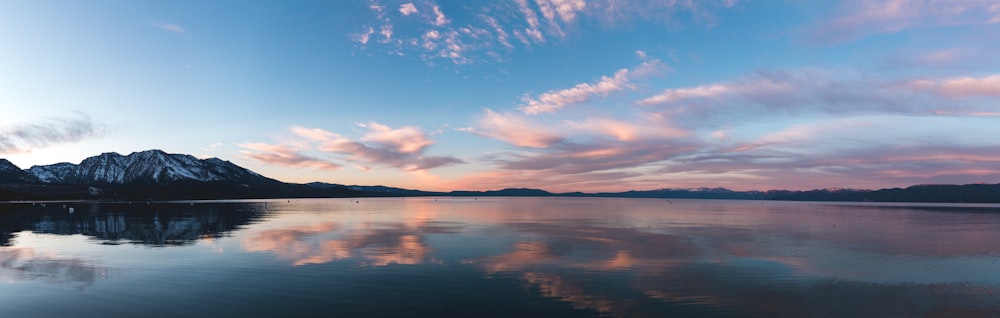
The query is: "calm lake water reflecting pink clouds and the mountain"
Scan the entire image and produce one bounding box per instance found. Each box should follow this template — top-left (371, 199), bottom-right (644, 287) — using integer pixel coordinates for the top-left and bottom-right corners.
top-left (0, 198), bottom-right (1000, 318)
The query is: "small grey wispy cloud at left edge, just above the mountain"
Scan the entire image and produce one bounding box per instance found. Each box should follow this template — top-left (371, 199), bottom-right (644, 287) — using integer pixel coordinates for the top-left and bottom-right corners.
top-left (0, 112), bottom-right (104, 154)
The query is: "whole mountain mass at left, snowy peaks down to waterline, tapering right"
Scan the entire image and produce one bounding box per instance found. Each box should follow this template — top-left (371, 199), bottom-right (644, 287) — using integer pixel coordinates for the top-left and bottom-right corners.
top-left (0, 150), bottom-right (364, 200)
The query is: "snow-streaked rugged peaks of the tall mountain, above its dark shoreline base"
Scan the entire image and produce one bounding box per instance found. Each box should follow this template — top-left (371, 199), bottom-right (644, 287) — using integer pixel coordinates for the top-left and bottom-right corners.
top-left (27, 150), bottom-right (277, 185)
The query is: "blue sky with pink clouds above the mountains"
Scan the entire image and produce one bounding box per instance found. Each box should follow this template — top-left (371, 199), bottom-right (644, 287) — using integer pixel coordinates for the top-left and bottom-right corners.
top-left (0, 0), bottom-right (1000, 192)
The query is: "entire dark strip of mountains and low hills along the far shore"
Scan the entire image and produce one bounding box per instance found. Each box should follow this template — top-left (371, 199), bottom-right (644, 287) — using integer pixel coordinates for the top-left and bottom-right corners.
top-left (0, 150), bottom-right (1000, 203)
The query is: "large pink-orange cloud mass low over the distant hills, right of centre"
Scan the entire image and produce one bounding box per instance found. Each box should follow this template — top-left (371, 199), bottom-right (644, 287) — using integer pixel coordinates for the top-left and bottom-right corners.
top-left (452, 109), bottom-right (697, 191)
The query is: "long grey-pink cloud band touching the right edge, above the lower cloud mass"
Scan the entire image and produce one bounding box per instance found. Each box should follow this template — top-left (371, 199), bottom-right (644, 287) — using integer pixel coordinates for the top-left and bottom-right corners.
top-left (635, 68), bottom-right (1000, 127)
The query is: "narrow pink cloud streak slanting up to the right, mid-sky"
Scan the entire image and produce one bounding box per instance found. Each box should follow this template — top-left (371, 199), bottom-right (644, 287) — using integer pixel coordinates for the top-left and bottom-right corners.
top-left (518, 60), bottom-right (665, 115)
